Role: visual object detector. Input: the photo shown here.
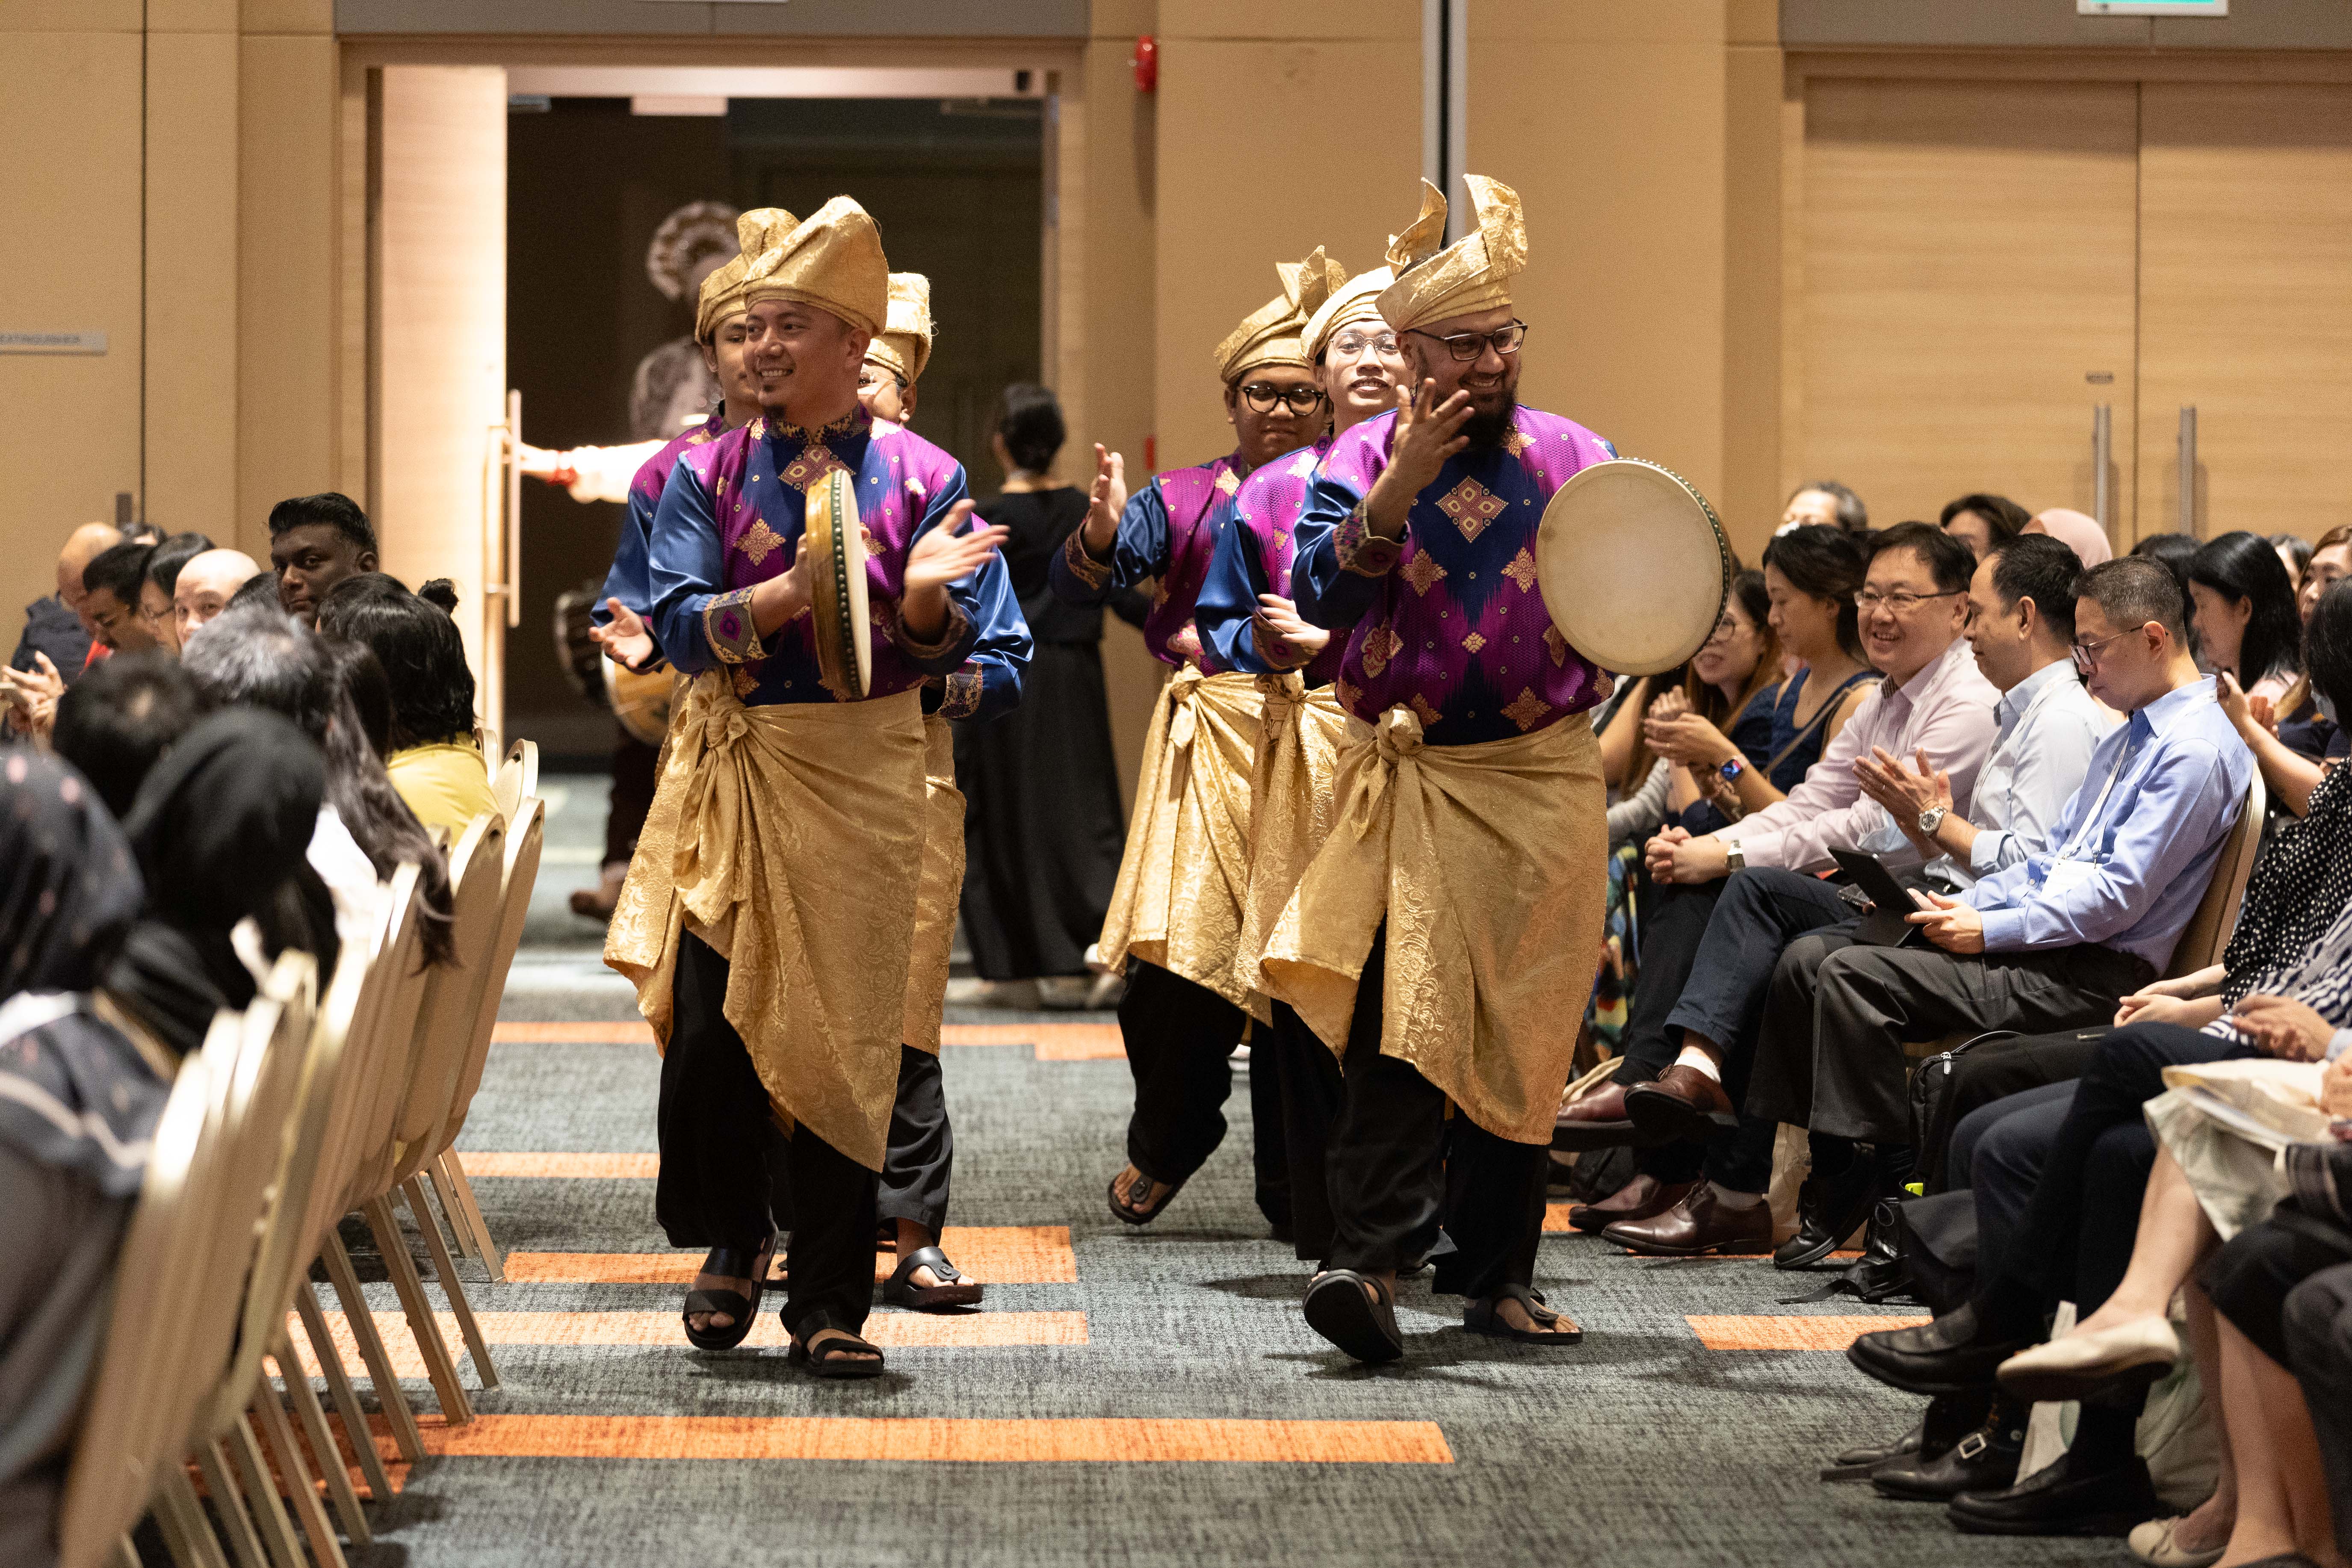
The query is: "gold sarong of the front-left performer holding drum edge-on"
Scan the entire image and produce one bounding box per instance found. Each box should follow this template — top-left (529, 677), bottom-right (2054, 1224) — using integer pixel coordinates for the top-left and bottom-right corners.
top-left (605, 670), bottom-right (925, 1171)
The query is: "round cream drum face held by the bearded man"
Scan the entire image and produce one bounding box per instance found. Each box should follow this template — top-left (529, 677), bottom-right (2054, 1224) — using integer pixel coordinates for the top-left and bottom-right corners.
top-left (1536, 458), bottom-right (1731, 675)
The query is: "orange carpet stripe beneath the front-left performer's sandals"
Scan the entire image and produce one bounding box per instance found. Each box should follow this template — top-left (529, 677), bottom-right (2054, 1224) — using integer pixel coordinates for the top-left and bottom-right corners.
top-left (290, 1312), bottom-right (1087, 1378)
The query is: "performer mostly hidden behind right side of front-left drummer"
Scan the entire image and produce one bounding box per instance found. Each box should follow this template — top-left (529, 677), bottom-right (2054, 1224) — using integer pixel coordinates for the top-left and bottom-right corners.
top-left (859, 273), bottom-right (1030, 1309)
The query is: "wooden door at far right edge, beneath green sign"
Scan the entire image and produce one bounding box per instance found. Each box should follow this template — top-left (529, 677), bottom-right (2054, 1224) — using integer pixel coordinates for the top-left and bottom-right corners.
top-left (2138, 82), bottom-right (2352, 552)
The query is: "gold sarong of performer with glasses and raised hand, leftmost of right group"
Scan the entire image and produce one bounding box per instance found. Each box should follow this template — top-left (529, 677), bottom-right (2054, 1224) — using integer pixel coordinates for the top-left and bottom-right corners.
top-left (1096, 665), bottom-right (1261, 1006)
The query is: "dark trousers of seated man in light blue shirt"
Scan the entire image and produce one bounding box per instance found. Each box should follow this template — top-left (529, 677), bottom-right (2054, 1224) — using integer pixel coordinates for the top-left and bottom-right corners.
top-left (1748, 931), bottom-right (2154, 1147)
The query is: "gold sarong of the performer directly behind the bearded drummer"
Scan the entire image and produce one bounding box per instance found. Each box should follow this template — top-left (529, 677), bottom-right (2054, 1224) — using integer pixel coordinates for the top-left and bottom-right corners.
top-left (1232, 672), bottom-right (1348, 1023)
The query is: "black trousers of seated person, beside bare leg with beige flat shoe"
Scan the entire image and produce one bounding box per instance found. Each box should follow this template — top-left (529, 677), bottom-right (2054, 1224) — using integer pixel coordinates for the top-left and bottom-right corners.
top-left (1978, 1023), bottom-right (2251, 1338)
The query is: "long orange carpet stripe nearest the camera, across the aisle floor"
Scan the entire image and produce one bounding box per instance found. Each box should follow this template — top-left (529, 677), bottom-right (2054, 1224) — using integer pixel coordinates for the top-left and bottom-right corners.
top-left (423, 1415), bottom-right (1454, 1465)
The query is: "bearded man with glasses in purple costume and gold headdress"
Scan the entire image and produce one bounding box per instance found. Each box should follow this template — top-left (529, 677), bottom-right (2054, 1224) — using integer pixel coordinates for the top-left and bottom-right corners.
top-left (1261, 174), bottom-right (1616, 1361)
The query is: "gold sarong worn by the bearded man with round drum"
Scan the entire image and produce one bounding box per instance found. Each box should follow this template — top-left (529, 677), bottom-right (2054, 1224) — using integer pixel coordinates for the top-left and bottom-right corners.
top-left (1259, 708), bottom-right (1609, 1143)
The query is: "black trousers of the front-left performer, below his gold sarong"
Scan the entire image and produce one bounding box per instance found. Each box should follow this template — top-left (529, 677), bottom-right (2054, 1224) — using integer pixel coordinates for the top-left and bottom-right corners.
top-left (654, 933), bottom-right (878, 1333)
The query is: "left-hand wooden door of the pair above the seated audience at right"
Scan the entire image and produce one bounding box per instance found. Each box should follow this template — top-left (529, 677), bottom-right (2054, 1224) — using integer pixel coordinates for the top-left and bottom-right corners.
top-left (1785, 77), bottom-right (2138, 534)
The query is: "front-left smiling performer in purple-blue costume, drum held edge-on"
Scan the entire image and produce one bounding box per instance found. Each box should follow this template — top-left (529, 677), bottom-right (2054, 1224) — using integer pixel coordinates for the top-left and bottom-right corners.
top-left (605, 198), bottom-right (1000, 1378)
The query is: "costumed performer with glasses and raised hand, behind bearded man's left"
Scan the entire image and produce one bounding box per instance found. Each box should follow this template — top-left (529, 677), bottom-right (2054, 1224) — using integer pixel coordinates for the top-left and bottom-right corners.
top-left (1052, 249), bottom-right (1345, 1234)
